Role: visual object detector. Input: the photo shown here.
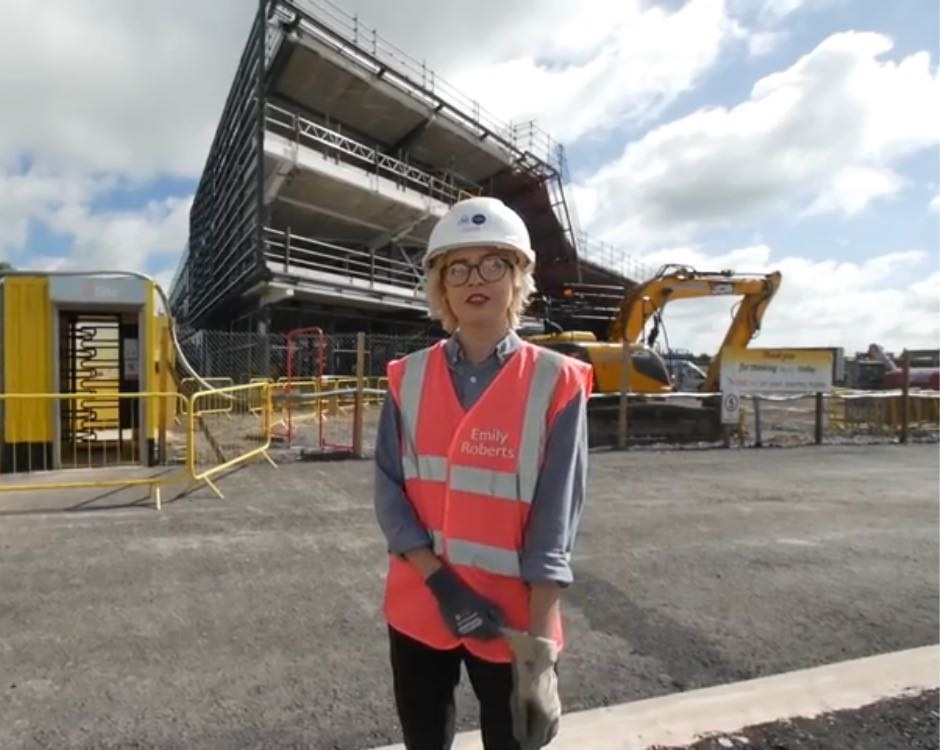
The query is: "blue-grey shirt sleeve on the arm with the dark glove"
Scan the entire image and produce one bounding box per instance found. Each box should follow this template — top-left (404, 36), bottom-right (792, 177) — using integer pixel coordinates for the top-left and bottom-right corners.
top-left (373, 396), bottom-right (431, 555)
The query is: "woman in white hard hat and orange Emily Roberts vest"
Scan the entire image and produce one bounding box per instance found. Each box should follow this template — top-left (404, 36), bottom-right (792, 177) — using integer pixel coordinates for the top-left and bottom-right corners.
top-left (375, 198), bottom-right (592, 750)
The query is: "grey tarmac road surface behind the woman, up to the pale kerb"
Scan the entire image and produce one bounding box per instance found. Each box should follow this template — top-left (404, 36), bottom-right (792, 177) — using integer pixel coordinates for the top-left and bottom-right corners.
top-left (0, 445), bottom-right (940, 750)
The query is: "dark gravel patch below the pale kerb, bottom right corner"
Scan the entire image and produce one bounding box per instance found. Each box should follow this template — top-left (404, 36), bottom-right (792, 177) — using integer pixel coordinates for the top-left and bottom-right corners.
top-left (655, 690), bottom-right (940, 750)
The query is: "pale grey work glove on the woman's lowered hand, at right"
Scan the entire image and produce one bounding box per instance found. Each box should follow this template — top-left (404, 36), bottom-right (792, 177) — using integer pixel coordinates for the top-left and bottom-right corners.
top-left (503, 628), bottom-right (561, 750)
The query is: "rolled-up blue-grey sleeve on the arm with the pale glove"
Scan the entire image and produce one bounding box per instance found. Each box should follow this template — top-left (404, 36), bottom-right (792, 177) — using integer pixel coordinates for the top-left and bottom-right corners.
top-left (522, 391), bottom-right (588, 586)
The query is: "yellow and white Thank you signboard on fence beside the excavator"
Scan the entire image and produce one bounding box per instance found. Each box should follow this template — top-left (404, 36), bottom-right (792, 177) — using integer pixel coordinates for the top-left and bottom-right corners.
top-left (721, 347), bottom-right (832, 396)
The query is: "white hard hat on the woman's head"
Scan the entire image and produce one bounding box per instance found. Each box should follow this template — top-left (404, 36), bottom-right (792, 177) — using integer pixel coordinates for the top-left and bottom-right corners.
top-left (424, 197), bottom-right (535, 272)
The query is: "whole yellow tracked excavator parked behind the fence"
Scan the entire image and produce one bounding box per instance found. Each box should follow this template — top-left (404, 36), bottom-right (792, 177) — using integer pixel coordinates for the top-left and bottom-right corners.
top-left (525, 264), bottom-right (781, 445)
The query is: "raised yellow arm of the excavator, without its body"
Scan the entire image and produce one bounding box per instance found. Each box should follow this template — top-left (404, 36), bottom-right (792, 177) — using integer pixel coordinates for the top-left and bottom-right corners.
top-left (608, 265), bottom-right (781, 391)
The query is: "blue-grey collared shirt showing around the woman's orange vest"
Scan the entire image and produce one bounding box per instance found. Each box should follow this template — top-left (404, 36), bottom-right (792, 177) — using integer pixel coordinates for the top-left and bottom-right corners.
top-left (374, 332), bottom-right (588, 585)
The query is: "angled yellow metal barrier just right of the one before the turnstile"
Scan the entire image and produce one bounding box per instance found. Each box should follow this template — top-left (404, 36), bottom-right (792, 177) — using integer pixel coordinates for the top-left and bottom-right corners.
top-left (186, 382), bottom-right (277, 498)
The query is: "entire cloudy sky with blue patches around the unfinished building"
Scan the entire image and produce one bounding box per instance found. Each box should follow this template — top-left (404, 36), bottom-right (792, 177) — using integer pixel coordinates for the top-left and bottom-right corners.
top-left (0, 0), bottom-right (940, 352)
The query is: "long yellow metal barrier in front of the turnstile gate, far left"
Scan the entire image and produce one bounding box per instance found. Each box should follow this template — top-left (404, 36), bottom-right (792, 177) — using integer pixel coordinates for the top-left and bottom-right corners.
top-left (0, 392), bottom-right (186, 509)
